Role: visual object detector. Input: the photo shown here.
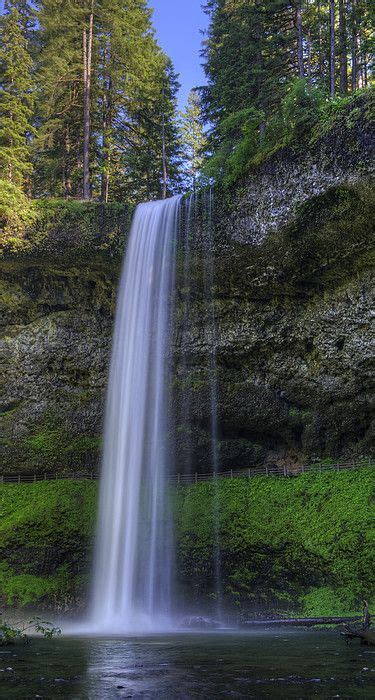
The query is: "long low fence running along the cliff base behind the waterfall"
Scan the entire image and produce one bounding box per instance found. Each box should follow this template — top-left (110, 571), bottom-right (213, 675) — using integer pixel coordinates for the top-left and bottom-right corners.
top-left (0, 459), bottom-right (375, 486)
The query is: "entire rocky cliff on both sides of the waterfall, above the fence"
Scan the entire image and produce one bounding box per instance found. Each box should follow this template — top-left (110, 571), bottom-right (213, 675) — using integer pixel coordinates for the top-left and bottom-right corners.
top-left (0, 97), bottom-right (372, 473)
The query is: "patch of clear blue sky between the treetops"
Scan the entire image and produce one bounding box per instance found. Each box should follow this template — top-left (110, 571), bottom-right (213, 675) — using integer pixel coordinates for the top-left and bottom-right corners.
top-left (149, 0), bottom-right (207, 109)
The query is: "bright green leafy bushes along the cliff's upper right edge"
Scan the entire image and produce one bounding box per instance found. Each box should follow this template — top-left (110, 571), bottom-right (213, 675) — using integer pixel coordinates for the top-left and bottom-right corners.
top-left (205, 85), bottom-right (372, 187)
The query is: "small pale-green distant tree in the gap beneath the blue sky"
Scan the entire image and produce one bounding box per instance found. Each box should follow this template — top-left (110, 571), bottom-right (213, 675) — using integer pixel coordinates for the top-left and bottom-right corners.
top-left (181, 90), bottom-right (207, 192)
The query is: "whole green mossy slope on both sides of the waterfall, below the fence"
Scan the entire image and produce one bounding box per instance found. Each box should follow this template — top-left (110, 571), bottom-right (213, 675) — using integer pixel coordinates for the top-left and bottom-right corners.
top-left (0, 468), bottom-right (375, 615)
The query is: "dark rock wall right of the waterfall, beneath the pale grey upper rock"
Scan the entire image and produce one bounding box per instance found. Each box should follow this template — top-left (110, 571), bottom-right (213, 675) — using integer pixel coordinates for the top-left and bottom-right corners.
top-left (178, 183), bottom-right (373, 471)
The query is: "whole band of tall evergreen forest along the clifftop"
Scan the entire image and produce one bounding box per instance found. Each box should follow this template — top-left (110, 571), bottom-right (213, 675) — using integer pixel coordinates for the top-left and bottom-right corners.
top-left (0, 0), bottom-right (373, 206)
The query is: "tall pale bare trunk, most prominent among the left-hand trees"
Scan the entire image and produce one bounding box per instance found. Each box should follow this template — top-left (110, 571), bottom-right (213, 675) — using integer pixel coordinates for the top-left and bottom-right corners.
top-left (83, 0), bottom-right (94, 200)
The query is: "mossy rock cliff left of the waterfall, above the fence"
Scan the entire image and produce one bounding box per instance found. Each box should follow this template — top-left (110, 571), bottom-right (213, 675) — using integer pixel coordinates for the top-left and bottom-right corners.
top-left (0, 203), bottom-right (128, 474)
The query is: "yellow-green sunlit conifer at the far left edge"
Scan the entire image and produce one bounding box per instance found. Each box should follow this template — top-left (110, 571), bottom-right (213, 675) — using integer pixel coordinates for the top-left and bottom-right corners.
top-left (0, 3), bottom-right (33, 187)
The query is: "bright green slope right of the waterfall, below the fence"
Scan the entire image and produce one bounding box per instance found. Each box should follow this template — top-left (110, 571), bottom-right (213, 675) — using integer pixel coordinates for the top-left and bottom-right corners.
top-left (175, 469), bottom-right (375, 616)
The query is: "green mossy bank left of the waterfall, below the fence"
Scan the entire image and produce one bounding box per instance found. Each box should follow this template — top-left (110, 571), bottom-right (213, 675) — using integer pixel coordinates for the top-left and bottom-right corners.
top-left (0, 481), bottom-right (97, 608)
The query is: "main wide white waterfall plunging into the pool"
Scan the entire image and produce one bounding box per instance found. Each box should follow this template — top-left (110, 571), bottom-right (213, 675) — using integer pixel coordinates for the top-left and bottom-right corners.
top-left (91, 197), bottom-right (180, 632)
